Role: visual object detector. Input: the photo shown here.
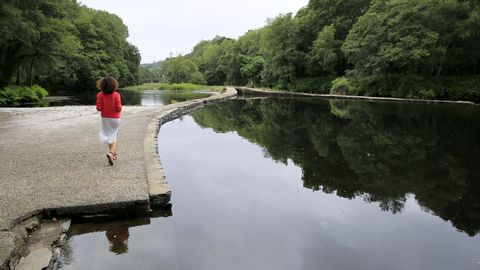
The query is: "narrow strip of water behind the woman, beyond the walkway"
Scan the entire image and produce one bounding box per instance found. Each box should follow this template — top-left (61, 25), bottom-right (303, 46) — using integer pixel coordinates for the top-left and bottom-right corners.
top-left (40, 90), bottom-right (216, 107)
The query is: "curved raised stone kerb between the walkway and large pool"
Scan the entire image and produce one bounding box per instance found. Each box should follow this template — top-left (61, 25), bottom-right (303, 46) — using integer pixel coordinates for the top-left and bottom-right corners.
top-left (143, 87), bottom-right (237, 206)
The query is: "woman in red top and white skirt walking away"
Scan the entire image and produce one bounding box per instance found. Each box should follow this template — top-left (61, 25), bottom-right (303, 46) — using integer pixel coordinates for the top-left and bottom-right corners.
top-left (97, 77), bottom-right (122, 165)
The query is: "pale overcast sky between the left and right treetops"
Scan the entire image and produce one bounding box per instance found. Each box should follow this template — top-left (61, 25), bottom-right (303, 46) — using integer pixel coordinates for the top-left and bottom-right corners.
top-left (79, 0), bottom-right (308, 63)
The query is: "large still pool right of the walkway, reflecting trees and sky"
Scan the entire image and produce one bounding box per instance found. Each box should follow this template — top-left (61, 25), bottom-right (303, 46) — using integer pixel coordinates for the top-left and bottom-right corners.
top-left (59, 99), bottom-right (480, 269)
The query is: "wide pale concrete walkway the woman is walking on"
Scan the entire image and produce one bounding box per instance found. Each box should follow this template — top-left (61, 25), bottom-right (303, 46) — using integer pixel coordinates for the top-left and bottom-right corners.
top-left (0, 88), bottom-right (236, 268)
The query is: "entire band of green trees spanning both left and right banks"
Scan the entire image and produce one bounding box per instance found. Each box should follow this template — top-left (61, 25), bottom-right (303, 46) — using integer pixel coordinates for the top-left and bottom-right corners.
top-left (0, 0), bottom-right (480, 103)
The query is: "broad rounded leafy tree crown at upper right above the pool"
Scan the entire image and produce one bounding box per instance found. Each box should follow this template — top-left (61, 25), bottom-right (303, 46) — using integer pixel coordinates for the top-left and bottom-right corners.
top-left (343, 0), bottom-right (441, 76)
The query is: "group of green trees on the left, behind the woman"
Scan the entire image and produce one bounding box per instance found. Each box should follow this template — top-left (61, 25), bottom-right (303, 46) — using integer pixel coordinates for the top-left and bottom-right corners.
top-left (0, 0), bottom-right (140, 102)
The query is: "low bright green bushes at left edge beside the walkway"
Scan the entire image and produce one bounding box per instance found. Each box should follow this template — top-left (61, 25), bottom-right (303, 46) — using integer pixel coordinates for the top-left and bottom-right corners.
top-left (0, 85), bottom-right (48, 105)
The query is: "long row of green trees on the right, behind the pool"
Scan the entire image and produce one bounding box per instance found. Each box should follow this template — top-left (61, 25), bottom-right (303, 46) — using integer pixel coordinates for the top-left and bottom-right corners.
top-left (145, 0), bottom-right (480, 102)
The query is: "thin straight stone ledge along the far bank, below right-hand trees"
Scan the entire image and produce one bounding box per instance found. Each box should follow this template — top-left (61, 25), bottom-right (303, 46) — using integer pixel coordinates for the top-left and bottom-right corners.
top-left (235, 87), bottom-right (478, 105)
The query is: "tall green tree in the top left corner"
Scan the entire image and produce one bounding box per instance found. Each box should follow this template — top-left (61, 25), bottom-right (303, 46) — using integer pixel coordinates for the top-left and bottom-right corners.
top-left (0, 0), bottom-right (80, 87)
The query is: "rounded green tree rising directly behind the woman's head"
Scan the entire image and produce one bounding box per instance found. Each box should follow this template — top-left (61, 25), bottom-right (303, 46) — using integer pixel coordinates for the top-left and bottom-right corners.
top-left (69, 7), bottom-right (140, 88)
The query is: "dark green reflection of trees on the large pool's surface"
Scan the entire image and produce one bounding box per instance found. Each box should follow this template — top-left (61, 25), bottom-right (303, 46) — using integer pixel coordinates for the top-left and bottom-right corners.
top-left (192, 98), bottom-right (480, 236)
